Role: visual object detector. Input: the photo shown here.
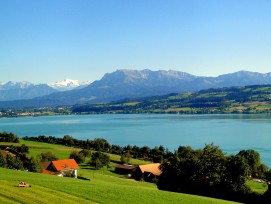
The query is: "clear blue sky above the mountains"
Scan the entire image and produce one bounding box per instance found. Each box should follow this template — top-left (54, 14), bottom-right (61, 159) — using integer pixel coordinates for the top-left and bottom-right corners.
top-left (0, 0), bottom-right (271, 83)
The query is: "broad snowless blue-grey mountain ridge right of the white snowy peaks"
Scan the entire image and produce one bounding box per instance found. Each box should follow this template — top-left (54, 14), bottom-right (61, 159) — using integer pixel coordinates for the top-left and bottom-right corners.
top-left (0, 69), bottom-right (271, 107)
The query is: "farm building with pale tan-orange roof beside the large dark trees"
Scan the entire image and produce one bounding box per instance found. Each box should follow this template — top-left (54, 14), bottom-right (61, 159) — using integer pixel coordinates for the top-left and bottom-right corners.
top-left (134, 163), bottom-right (162, 181)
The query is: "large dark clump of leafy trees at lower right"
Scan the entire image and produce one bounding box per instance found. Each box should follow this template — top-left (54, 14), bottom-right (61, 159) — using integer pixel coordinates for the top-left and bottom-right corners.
top-left (157, 144), bottom-right (271, 203)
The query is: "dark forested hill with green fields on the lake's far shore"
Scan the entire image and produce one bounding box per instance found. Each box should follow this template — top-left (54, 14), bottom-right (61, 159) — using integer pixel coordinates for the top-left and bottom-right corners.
top-left (72, 85), bottom-right (271, 114)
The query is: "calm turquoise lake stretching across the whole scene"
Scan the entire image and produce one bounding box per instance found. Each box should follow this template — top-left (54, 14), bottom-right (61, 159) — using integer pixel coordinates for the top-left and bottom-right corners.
top-left (0, 114), bottom-right (271, 167)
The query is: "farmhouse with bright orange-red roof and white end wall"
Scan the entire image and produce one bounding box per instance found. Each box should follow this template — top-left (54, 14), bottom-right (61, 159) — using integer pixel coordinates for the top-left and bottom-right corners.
top-left (40, 159), bottom-right (79, 178)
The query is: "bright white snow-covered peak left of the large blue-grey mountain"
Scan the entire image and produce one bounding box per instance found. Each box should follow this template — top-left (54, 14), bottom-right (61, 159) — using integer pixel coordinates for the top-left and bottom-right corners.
top-left (48, 79), bottom-right (91, 91)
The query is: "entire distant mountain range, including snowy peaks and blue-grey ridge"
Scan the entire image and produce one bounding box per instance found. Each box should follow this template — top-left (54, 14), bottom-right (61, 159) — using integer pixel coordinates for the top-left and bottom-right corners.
top-left (0, 69), bottom-right (271, 108)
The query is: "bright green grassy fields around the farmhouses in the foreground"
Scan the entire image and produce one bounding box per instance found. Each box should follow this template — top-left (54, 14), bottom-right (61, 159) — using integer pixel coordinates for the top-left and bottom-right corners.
top-left (0, 140), bottom-right (246, 204)
